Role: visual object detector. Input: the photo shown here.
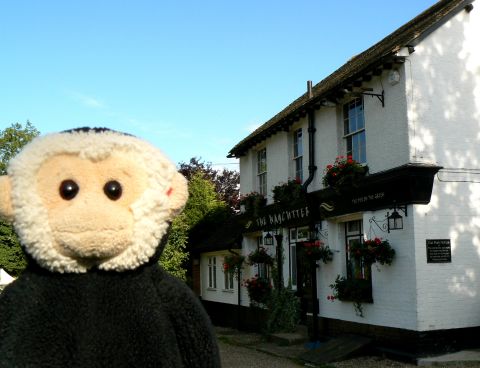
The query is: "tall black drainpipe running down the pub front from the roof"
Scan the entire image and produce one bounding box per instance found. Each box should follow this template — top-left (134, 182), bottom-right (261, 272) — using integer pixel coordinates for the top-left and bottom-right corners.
top-left (303, 81), bottom-right (320, 341)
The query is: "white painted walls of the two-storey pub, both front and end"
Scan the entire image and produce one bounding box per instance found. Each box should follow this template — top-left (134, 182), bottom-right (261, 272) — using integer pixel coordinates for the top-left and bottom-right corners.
top-left (234, 2), bottom-right (480, 331)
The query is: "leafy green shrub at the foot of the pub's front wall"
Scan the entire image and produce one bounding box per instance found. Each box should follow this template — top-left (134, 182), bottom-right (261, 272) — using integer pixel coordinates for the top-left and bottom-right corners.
top-left (265, 287), bottom-right (300, 334)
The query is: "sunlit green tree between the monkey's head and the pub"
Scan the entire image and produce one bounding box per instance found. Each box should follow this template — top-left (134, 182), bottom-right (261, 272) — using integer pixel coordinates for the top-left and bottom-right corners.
top-left (160, 172), bottom-right (227, 280)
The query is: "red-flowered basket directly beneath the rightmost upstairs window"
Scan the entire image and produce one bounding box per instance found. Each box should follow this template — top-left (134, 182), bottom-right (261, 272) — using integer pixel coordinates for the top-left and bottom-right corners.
top-left (322, 156), bottom-right (368, 188)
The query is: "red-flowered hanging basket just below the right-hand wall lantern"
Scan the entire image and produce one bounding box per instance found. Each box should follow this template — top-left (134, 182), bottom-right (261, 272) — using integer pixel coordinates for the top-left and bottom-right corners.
top-left (349, 238), bottom-right (395, 265)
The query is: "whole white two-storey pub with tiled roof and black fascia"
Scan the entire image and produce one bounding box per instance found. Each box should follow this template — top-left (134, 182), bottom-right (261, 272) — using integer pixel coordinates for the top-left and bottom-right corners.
top-left (193, 0), bottom-right (480, 353)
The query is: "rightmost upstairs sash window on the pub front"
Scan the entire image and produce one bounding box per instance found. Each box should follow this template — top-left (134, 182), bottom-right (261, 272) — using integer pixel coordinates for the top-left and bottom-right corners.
top-left (343, 98), bottom-right (367, 163)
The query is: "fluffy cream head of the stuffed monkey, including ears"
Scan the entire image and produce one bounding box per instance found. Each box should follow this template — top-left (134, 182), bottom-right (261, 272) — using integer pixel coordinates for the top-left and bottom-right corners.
top-left (0, 128), bottom-right (188, 273)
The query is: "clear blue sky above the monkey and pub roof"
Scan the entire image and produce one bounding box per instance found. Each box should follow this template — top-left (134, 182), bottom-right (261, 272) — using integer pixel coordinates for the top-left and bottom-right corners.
top-left (0, 0), bottom-right (435, 169)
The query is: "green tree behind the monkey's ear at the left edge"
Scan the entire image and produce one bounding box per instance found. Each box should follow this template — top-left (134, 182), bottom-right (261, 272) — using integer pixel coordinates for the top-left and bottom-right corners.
top-left (0, 121), bottom-right (40, 276)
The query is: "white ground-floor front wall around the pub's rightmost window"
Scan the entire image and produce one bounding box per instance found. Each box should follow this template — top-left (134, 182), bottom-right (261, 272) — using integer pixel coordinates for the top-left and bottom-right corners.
top-left (317, 210), bottom-right (416, 330)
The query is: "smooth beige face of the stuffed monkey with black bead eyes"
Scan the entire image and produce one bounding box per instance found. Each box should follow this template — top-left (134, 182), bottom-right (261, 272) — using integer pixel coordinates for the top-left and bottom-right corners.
top-left (37, 152), bottom-right (147, 262)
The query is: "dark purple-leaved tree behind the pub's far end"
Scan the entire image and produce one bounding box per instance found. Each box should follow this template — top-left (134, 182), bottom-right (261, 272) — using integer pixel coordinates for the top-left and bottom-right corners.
top-left (178, 157), bottom-right (240, 210)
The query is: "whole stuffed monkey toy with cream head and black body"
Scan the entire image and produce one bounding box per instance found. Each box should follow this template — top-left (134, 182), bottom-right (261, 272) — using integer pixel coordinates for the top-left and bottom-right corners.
top-left (0, 128), bottom-right (220, 368)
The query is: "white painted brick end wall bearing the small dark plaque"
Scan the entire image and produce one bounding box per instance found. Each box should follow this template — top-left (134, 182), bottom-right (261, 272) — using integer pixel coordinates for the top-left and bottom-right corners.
top-left (407, 7), bottom-right (480, 331)
